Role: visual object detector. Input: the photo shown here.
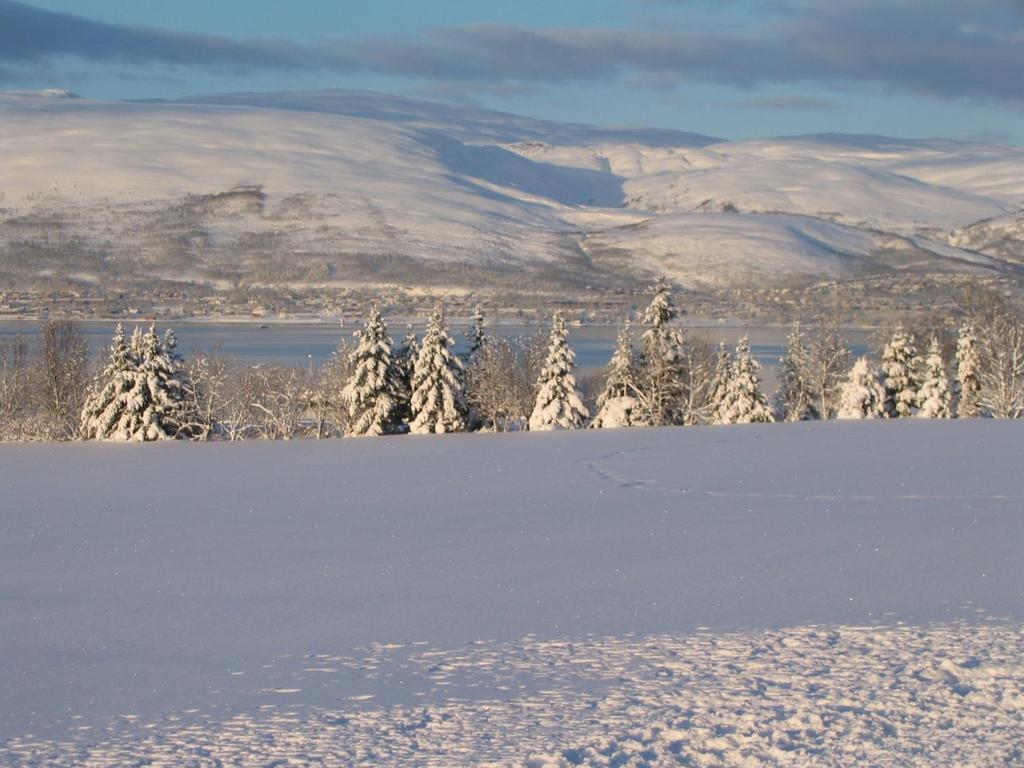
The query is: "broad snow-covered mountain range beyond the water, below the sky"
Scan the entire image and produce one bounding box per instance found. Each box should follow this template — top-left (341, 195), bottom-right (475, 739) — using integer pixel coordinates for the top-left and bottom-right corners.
top-left (0, 91), bottom-right (1024, 294)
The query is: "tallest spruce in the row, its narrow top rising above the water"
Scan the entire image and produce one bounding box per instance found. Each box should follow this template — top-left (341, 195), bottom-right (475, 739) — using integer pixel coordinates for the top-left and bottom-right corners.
top-left (637, 276), bottom-right (683, 427)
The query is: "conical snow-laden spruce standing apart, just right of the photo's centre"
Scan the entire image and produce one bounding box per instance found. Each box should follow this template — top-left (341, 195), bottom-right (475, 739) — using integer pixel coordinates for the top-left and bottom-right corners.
top-left (529, 312), bottom-right (590, 432)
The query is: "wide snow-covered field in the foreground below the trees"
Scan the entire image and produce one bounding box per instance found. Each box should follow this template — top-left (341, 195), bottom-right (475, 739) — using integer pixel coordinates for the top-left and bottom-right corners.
top-left (0, 421), bottom-right (1024, 766)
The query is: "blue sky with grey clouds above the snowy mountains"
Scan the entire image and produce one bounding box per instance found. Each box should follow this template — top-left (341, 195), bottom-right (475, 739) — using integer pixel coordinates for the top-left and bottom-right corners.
top-left (0, 0), bottom-right (1024, 144)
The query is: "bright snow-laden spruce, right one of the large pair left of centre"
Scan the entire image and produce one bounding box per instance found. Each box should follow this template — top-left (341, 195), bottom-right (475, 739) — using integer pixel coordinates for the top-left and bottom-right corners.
top-left (409, 306), bottom-right (467, 434)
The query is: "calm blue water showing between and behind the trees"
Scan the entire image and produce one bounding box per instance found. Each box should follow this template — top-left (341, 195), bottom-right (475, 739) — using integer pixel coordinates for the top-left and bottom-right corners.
top-left (0, 322), bottom-right (869, 371)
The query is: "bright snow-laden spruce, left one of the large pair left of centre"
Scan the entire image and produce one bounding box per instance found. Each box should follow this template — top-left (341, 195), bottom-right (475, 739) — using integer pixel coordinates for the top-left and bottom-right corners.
top-left (341, 307), bottom-right (401, 436)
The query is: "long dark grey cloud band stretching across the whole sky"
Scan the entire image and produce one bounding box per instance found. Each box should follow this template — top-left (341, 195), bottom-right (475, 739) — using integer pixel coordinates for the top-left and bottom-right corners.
top-left (0, 0), bottom-right (1024, 109)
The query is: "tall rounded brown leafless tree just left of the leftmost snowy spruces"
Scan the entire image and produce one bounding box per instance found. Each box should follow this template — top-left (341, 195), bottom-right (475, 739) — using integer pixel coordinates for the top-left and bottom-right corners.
top-left (33, 321), bottom-right (89, 440)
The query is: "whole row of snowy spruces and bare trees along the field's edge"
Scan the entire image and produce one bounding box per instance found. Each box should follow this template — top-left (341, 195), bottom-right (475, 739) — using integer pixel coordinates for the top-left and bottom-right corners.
top-left (6, 279), bottom-right (1024, 441)
